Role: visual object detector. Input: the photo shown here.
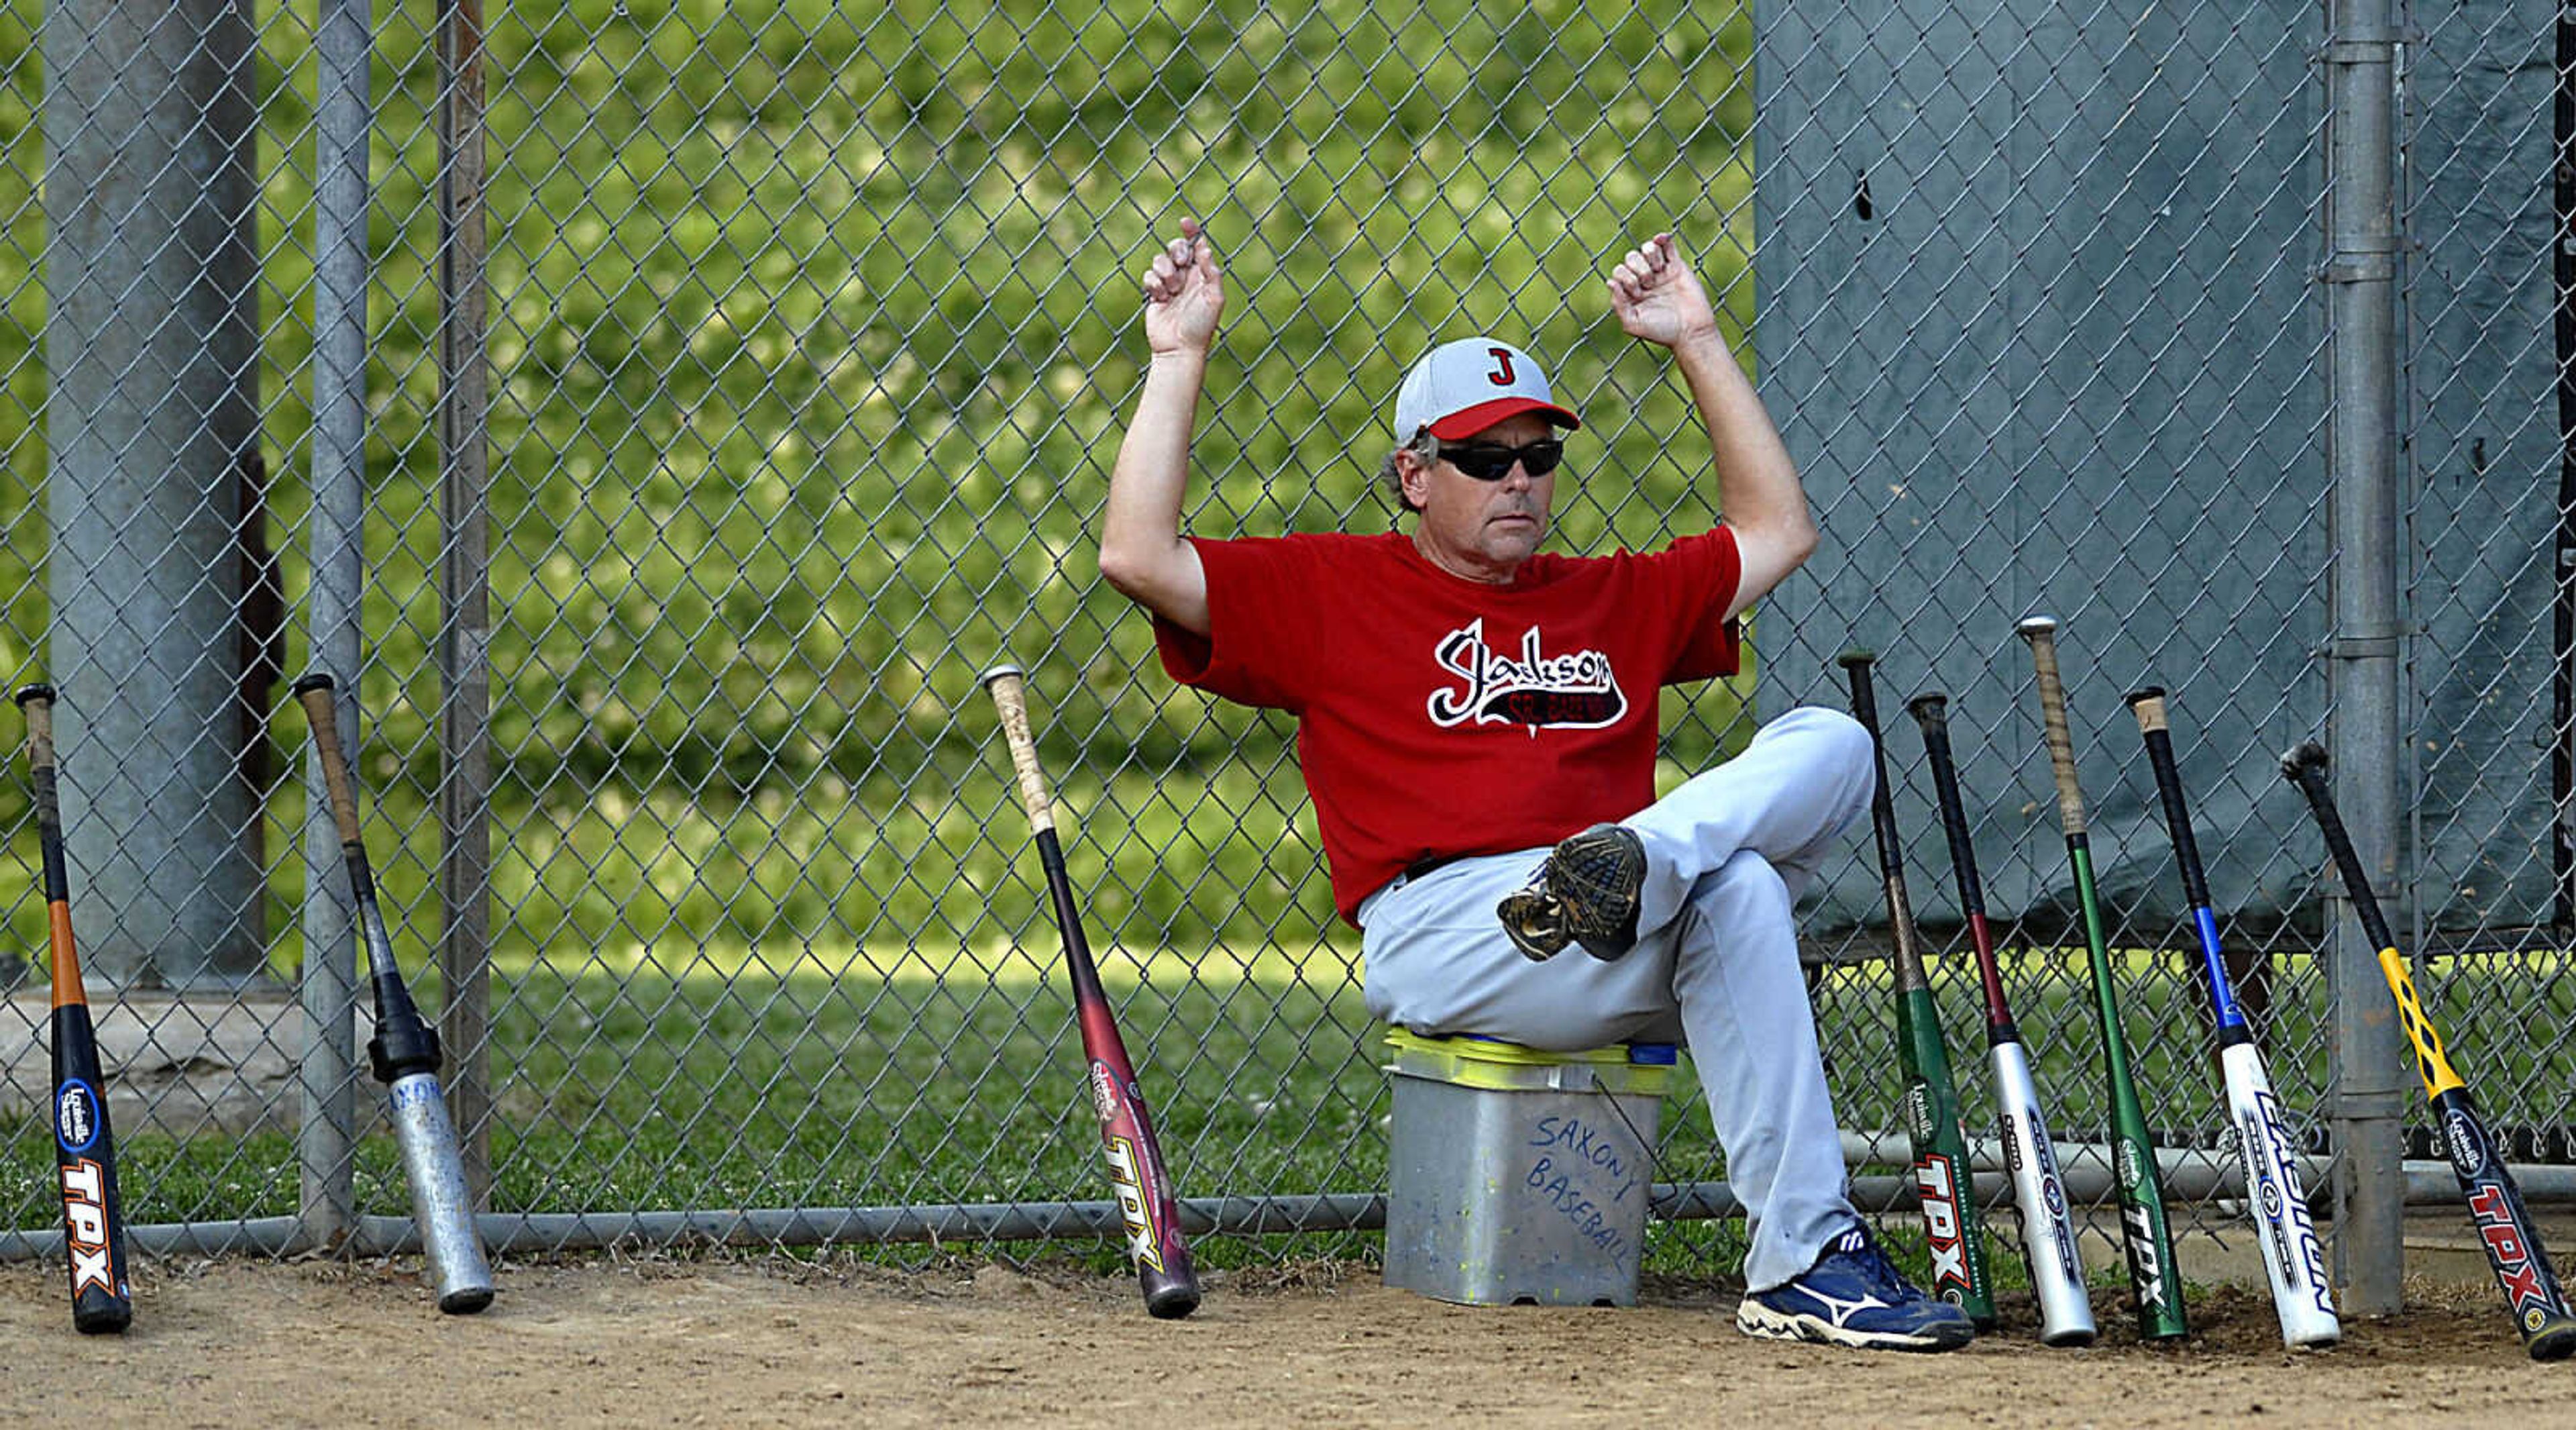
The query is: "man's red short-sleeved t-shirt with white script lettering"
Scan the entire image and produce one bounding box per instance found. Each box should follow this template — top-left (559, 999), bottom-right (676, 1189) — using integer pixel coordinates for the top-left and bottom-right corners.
top-left (1154, 525), bottom-right (1741, 920)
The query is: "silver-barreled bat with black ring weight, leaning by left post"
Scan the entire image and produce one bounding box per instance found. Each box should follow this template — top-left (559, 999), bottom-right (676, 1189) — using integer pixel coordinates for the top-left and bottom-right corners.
top-left (294, 672), bottom-right (492, 1317)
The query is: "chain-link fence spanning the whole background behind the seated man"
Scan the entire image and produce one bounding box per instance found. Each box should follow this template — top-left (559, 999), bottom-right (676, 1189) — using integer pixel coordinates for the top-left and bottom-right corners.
top-left (0, 0), bottom-right (2576, 1298)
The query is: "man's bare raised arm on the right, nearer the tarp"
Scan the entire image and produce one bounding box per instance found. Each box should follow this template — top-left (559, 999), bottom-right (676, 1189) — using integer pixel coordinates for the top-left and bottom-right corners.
top-left (1610, 234), bottom-right (1816, 616)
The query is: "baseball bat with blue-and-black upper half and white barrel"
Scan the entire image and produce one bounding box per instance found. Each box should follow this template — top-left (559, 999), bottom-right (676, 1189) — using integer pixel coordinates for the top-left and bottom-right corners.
top-left (2128, 685), bottom-right (2344, 1347)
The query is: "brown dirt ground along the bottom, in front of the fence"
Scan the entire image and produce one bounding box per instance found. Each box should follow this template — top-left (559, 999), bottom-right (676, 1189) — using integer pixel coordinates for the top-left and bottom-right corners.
top-left (0, 1258), bottom-right (2576, 1430)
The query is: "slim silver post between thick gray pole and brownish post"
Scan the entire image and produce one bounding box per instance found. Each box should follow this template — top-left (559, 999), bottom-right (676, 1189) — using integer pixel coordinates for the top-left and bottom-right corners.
top-left (297, 0), bottom-right (371, 1245)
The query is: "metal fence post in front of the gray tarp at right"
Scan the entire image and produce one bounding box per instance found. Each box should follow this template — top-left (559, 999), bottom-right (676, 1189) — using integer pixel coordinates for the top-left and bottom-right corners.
top-left (2324, 0), bottom-right (2411, 1317)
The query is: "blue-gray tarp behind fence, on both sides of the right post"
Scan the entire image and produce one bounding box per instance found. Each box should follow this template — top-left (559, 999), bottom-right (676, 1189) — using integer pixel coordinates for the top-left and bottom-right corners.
top-left (1754, 0), bottom-right (2558, 935)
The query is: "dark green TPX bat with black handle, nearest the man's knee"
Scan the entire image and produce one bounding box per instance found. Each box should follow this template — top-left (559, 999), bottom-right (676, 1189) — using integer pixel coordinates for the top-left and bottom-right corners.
top-left (1839, 650), bottom-right (1994, 1329)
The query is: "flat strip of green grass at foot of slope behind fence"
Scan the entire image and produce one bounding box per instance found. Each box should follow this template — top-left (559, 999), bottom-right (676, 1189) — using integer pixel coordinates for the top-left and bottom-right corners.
top-left (35, 953), bottom-right (2527, 1241)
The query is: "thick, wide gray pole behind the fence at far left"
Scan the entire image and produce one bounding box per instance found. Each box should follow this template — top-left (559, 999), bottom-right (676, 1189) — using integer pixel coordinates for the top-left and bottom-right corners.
top-left (42, 0), bottom-right (263, 994)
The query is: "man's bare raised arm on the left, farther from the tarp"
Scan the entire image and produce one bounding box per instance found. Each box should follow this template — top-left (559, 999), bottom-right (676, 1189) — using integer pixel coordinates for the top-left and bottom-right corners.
top-left (1100, 219), bottom-right (1226, 636)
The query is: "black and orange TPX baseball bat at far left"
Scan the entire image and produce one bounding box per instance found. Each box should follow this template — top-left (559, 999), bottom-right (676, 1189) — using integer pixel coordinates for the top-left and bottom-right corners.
top-left (18, 685), bottom-right (134, 1335)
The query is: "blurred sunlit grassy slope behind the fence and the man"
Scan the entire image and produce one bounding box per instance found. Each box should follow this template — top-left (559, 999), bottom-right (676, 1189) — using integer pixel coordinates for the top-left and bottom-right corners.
top-left (0, 0), bottom-right (1752, 966)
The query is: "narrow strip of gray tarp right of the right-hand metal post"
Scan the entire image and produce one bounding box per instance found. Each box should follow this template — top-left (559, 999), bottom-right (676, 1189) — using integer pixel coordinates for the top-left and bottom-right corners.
top-left (2401, 0), bottom-right (2566, 940)
